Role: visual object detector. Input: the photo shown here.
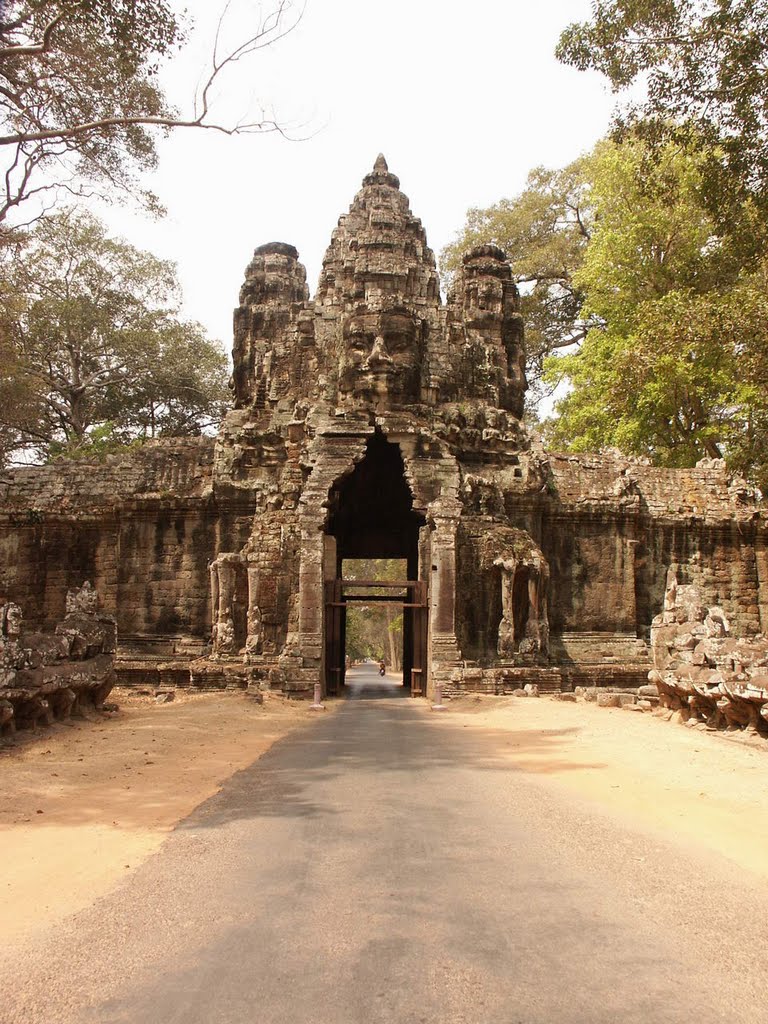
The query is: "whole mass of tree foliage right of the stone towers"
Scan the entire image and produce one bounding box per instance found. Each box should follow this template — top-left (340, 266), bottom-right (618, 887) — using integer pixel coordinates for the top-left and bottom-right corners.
top-left (443, 0), bottom-right (768, 489)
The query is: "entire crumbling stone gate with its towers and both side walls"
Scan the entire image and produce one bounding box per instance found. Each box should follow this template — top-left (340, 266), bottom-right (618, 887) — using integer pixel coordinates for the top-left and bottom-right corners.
top-left (0, 157), bottom-right (768, 694)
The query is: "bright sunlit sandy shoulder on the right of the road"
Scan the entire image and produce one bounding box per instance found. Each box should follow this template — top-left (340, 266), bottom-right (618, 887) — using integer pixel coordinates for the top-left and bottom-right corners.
top-left (444, 697), bottom-right (768, 879)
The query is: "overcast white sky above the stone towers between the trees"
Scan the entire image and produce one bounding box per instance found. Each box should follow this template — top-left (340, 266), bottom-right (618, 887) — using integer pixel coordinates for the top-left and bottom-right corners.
top-left (99, 0), bottom-right (612, 351)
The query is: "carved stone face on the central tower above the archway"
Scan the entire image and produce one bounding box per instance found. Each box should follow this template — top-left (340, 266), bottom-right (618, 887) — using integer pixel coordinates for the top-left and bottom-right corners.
top-left (339, 310), bottom-right (421, 401)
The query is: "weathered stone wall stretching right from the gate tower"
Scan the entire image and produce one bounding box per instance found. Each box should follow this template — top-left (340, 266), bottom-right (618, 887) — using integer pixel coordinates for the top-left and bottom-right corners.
top-left (543, 454), bottom-right (768, 639)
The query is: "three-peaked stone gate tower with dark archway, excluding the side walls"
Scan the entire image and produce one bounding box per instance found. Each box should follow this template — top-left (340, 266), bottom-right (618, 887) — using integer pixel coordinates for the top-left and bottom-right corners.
top-left (212, 156), bottom-right (546, 696)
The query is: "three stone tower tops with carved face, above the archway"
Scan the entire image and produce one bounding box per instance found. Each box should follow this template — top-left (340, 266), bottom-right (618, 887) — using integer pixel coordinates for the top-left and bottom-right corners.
top-left (232, 150), bottom-right (525, 418)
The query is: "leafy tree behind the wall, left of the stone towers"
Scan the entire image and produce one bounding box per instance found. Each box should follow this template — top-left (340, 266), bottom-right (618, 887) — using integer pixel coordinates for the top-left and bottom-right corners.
top-left (0, 211), bottom-right (226, 459)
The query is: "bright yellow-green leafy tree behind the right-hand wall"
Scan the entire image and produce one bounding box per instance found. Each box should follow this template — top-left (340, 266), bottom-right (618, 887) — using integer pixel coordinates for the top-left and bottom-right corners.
top-left (547, 141), bottom-right (768, 487)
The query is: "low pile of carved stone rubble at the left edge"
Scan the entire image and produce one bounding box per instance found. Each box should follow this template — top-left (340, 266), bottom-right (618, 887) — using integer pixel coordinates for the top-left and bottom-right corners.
top-left (0, 583), bottom-right (117, 735)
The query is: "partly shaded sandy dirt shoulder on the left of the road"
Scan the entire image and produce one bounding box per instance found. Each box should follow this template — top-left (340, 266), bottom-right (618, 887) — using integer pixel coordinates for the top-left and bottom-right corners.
top-left (0, 690), bottom-right (331, 942)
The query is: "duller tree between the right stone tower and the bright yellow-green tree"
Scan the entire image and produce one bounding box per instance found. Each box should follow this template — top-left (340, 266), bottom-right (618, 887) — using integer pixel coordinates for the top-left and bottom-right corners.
top-left (440, 146), bottom-right (601, 407)
